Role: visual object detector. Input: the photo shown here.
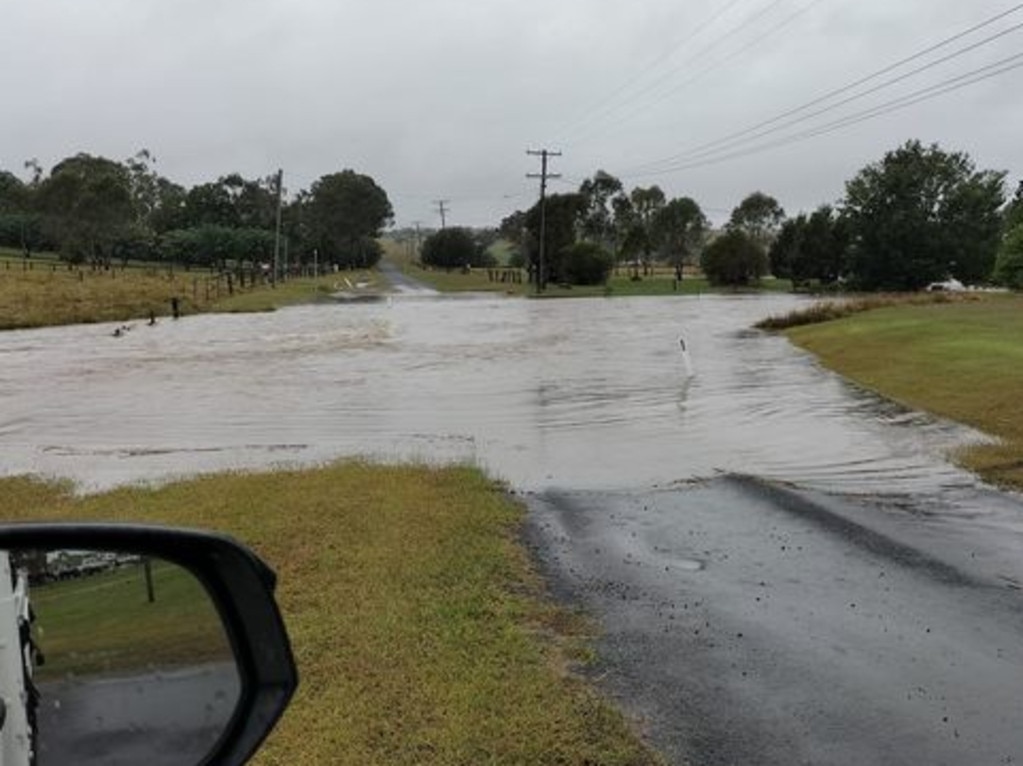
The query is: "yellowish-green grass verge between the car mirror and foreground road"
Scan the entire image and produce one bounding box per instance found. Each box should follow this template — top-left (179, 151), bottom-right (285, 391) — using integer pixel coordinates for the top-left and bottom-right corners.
top-left (0, 464), bottom-right (659, 765)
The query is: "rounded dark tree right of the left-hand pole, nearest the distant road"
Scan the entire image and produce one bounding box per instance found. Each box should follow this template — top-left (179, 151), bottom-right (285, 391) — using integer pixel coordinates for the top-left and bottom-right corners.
top-left (306, 170), bottom-right (394, 268)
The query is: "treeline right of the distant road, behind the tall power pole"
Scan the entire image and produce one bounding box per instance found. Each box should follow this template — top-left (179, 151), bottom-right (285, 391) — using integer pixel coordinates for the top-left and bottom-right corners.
top-left (499, 141), bottom-right (1023, 290)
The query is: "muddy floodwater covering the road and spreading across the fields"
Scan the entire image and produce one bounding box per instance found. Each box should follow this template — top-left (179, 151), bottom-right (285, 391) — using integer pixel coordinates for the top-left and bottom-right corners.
top-left (0, 296), bottom-right (982, 495)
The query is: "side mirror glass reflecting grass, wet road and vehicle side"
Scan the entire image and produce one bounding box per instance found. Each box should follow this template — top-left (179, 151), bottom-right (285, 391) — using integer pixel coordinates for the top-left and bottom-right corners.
top-left (0, 550), bottom-right (240, 766)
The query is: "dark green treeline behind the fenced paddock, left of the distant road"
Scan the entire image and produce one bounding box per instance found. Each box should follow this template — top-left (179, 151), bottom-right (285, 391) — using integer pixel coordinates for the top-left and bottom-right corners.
top-left (0, 150), bottom-right (393, 268)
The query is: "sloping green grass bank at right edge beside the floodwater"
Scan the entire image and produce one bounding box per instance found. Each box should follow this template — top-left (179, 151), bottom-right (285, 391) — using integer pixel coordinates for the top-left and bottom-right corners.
top-left (788, 296), bottom-right (1023, 489)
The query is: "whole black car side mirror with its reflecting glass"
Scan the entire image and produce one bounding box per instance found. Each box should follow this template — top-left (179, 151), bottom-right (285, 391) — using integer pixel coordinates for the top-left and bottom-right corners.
top-left (0, 524), bottom-right (298, 766)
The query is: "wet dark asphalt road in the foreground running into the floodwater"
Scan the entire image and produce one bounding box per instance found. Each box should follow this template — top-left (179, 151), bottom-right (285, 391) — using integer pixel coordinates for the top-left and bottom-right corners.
top-left (527, 478), bottom-right (1023, 766)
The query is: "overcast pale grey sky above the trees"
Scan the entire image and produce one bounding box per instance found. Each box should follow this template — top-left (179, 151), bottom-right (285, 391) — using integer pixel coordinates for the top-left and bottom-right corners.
top-left (0, 0), bottom-right (1023, 225)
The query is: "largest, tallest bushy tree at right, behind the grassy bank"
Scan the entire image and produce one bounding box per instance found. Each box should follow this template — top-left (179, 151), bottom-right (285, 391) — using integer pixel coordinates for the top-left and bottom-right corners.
top-left (844, 141), bottom-right (1006, 290)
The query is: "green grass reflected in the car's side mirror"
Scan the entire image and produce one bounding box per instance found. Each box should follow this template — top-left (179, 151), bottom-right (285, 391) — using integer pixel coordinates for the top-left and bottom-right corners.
top-left (30, 561), bottom-right (230, 680)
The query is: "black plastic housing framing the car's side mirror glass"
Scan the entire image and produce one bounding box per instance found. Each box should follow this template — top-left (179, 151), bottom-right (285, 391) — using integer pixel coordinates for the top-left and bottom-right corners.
top-left (0, 524), bottom-right (298, 766)
